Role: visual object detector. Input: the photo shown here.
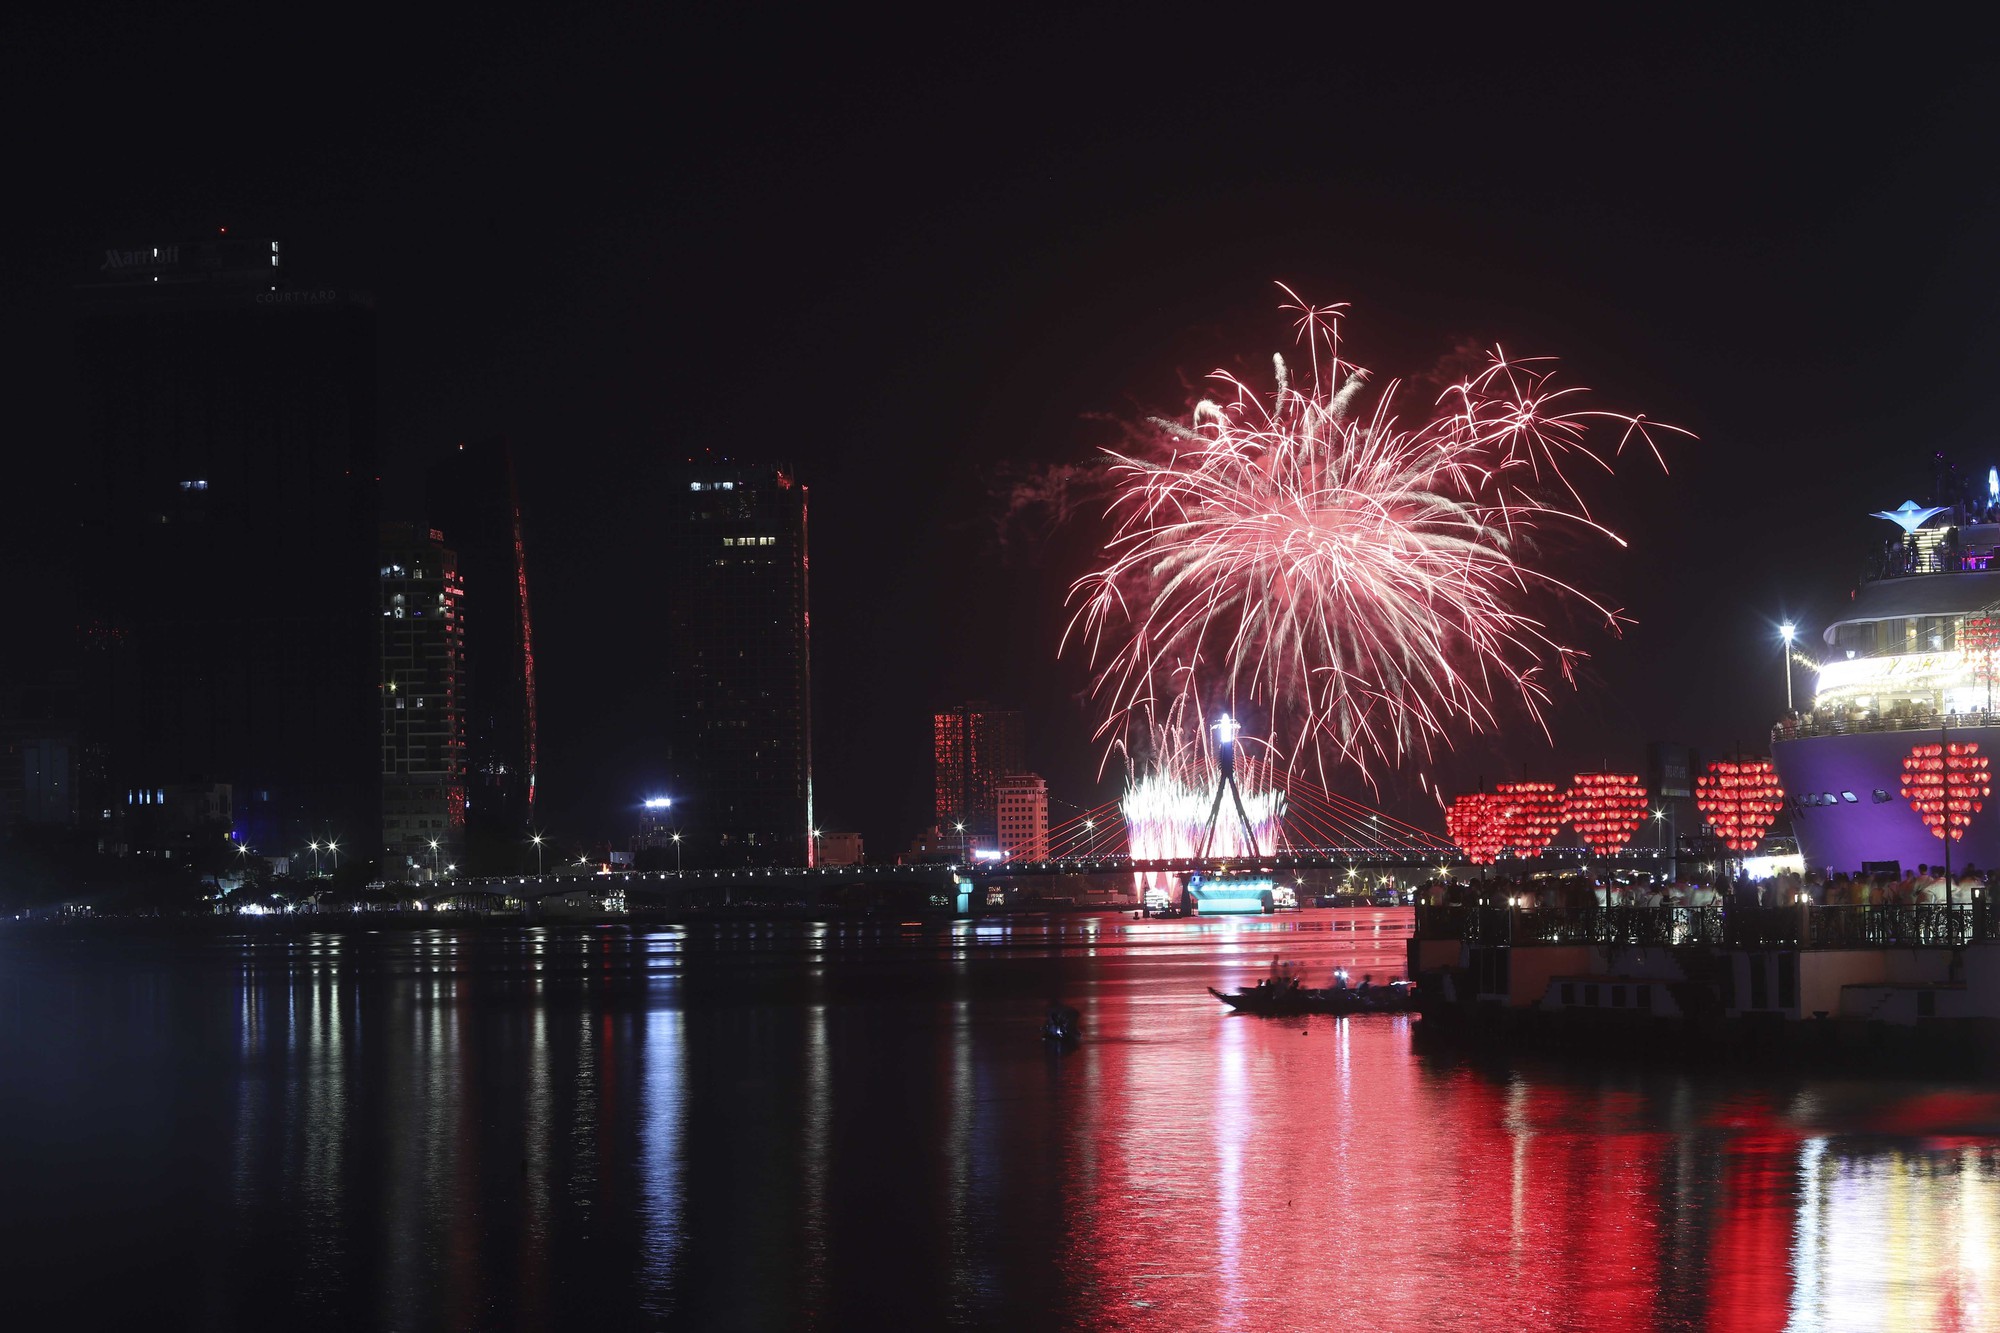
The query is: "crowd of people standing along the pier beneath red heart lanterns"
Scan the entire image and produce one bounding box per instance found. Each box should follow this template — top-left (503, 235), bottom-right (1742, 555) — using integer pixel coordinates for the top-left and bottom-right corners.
top-left (1416, 865), bottom-right (1986, 909)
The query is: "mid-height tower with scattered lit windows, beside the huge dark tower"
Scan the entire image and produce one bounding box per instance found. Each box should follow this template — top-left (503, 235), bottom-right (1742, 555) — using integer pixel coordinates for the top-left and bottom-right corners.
top-left (380, 522), bottom-right (466, 879)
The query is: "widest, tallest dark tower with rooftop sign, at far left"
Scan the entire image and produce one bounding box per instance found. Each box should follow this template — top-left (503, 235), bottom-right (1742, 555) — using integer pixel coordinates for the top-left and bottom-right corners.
top-left (76, 236), bottom-right (380, 853)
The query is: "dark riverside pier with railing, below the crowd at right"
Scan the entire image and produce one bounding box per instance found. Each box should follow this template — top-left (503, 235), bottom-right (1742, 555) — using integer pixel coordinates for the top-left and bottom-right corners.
top-left (1408, 899), bottom-right (2000, 1075)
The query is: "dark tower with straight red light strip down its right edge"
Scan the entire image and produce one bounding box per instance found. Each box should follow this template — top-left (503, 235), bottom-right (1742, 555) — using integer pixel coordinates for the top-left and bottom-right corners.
top-left (660, 464), bottom-right (812, 867)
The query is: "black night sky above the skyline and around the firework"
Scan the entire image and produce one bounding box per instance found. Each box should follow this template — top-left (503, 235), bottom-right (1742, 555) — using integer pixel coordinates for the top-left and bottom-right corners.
top-left (11, 6), bottom-right (2000, 851)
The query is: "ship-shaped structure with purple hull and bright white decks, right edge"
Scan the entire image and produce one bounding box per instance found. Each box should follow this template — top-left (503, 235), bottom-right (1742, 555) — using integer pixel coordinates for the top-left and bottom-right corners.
top-left (1772, 488), bottom-right (2000, 873)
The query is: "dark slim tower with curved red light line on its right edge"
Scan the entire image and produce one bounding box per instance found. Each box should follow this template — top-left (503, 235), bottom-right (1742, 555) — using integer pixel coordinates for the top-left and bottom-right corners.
top-left (424, 438), bottom-right (540, 875)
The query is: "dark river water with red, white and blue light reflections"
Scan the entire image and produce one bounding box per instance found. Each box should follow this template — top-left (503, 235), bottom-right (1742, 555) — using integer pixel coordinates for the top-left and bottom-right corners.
top-left (0, 911), bottom-right (2000, 1333)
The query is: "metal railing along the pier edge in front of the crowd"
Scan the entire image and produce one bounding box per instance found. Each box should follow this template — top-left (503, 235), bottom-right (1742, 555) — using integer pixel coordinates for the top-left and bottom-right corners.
top-left (1414, 901), bottom-right (2000, 949)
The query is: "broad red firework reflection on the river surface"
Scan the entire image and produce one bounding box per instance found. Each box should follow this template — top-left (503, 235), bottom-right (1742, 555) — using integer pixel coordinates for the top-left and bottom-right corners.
top-left (1068, 924), bottom-right (1736, 1333)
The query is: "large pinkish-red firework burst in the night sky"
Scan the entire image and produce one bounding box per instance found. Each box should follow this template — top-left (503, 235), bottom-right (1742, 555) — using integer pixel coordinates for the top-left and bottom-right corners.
top-left (1064, 288), bottom-right (1688, 781)
